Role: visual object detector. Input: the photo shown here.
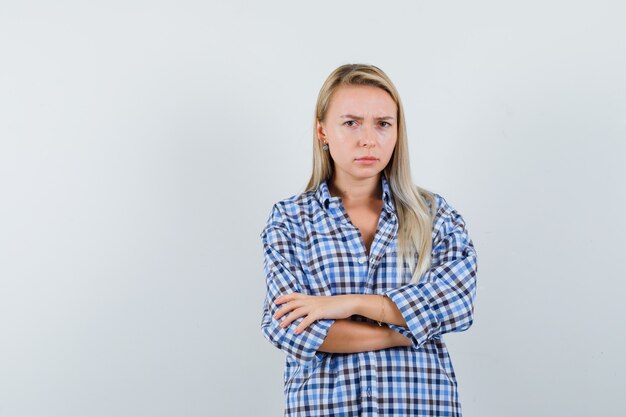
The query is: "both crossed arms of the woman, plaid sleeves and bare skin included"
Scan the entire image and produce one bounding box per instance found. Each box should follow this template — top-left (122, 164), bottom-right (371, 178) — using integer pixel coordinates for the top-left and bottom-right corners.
top-left (261, 198), bottom-right (478, 364)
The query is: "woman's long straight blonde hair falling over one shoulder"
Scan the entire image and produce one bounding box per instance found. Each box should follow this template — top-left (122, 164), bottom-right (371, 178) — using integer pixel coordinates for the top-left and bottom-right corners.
top-left (306, 64), bottom-right (437, 283)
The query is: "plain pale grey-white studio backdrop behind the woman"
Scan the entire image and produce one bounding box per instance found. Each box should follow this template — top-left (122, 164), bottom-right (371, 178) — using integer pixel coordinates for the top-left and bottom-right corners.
top-left (0, 0), bottom-right (626, 417)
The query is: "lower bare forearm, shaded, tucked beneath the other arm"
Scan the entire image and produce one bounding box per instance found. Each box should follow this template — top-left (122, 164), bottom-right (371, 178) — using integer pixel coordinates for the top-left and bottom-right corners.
top-left (318, 319), bottom-right (411, 353)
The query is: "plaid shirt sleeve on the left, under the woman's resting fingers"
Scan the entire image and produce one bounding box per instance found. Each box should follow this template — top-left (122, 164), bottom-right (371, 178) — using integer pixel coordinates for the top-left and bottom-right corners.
top-left (261, 205), bottom-right (335, 366)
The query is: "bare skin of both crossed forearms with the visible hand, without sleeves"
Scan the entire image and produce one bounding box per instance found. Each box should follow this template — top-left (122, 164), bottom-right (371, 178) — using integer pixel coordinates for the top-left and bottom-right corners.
top-left (273, 292), bottom-right (411, 353)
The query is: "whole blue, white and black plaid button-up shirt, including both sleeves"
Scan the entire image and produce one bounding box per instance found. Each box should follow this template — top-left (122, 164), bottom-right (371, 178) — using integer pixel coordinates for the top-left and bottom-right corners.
top-left (261, 173), bottom-right (477, 416)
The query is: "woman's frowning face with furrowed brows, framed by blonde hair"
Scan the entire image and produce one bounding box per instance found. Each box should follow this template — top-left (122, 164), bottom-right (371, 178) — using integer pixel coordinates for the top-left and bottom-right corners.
top-left (317, 85), bottom-right (398, 180)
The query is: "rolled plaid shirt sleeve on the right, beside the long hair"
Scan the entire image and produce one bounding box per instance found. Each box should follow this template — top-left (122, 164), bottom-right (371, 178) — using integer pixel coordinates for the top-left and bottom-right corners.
top-left (383, 195), bottom-right (478, 349)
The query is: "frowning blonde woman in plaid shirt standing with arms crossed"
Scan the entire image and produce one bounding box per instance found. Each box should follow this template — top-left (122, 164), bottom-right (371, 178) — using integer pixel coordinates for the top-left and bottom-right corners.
top-left (261, 65), bottom-right (477, 416)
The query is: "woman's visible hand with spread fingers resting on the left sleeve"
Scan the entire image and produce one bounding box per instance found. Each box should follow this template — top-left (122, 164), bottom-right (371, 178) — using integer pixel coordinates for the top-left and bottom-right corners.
top-left (274, 292), bottom-right (358, 334)
